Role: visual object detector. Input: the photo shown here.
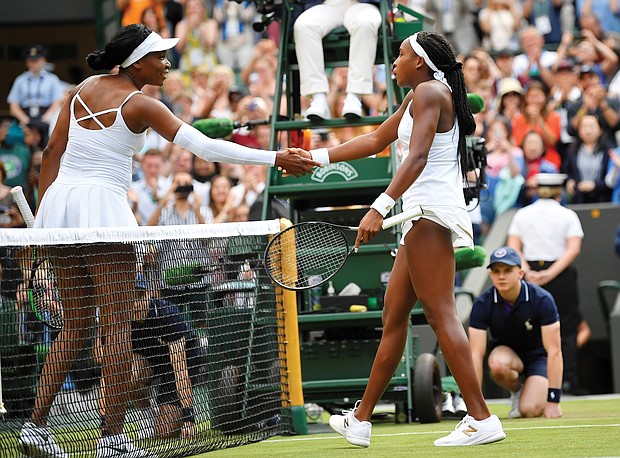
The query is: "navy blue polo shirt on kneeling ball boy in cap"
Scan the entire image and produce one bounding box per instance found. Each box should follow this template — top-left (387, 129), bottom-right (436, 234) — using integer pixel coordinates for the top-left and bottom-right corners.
top-left (469, 280), bottom-right (560, 354)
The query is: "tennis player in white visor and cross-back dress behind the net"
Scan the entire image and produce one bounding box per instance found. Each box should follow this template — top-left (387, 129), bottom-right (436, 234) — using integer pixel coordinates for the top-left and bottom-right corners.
top-left (19, 24), bottom-right (320, 458)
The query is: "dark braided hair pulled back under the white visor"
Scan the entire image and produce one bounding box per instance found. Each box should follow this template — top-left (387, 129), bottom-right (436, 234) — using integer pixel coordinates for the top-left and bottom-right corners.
top-left (86, 24), bottom-right (151, 70)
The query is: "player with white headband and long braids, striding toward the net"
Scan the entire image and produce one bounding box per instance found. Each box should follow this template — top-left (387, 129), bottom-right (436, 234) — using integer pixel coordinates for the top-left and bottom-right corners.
top-left (298, 32), bottom-right (506, 447)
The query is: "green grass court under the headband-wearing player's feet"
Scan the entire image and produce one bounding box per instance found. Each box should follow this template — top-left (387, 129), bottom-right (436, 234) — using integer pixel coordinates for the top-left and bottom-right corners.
top-left (202, 398), bottom-right (620, 458)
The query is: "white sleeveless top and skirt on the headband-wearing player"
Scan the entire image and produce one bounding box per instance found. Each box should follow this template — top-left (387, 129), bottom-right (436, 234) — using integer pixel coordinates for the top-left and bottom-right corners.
top-left (398, 102), bottom-right (474, 249)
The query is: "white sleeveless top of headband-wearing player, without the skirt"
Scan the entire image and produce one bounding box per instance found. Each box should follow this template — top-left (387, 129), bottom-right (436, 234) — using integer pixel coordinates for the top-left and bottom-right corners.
top-left (398, 102), bottom-right (465, 210)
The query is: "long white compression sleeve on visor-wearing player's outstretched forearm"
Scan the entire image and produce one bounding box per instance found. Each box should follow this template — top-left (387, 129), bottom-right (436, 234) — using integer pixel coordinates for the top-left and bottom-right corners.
top-left (173, 123), bottom-right (276, 166)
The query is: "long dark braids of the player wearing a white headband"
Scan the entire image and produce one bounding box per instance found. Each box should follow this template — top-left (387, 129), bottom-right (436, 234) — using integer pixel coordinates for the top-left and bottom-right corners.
top-left (417, 32), bottom-right (476, 176)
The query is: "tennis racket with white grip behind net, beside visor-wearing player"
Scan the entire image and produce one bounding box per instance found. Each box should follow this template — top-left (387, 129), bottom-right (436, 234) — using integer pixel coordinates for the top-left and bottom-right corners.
top-left (11, 186), bottom-right (62, 329)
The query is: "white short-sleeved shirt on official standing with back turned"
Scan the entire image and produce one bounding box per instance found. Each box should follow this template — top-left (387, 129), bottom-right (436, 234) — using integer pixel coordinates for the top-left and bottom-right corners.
top-left (508, 199), bottom-right (583, 262)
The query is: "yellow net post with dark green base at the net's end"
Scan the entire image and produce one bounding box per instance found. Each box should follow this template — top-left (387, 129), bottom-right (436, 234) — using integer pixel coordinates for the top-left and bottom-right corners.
top-left (277, 218), bottom-right (308, 435)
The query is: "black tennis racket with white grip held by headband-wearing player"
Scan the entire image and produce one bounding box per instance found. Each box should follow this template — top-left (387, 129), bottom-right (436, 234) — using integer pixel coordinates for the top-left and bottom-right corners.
top-left (263, 206), bottom-right (424, 291)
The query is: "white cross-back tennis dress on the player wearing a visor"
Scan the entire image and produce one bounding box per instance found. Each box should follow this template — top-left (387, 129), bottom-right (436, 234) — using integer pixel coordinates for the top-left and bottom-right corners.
top-left (34, 82), bottom-right (146, 228)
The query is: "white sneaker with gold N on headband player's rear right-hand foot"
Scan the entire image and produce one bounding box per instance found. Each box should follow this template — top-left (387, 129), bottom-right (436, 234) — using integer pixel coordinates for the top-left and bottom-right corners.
top-left (435, 415), bottom-right (506, 447)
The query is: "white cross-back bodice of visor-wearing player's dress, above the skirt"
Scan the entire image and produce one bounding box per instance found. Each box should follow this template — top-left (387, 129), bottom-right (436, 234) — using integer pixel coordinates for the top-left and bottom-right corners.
top-left (56, 77), bottom-right (146, 196)
